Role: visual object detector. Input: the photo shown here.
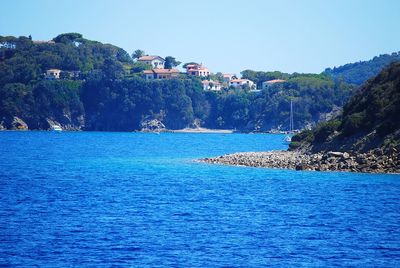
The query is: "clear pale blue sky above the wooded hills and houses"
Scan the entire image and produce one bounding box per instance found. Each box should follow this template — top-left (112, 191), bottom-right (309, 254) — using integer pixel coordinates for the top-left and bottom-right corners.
top-left (0, 0), bottom-right (400, 73)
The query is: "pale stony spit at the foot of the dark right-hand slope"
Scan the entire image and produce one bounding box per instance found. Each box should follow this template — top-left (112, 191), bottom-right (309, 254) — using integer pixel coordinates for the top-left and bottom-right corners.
top-left (199, 149), bottom-right (400, 173)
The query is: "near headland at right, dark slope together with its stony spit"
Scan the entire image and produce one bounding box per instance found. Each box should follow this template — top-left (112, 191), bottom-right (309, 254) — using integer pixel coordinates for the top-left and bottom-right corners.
top-left (200, 63), bottom-right (400, 173)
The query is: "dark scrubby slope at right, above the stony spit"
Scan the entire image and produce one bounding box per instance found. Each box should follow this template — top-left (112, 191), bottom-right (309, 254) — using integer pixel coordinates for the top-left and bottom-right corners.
top-left (290, 62), bottom-right (400, 152)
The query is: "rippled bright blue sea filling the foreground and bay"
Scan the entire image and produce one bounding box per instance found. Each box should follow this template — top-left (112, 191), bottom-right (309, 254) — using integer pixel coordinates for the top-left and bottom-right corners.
top-left (0, 132), bottom-right (400, 267)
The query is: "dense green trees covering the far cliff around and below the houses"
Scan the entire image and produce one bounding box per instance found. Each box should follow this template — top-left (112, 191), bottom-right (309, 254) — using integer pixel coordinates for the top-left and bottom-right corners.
top-left (0, 33), bottom-right (394, 131)
